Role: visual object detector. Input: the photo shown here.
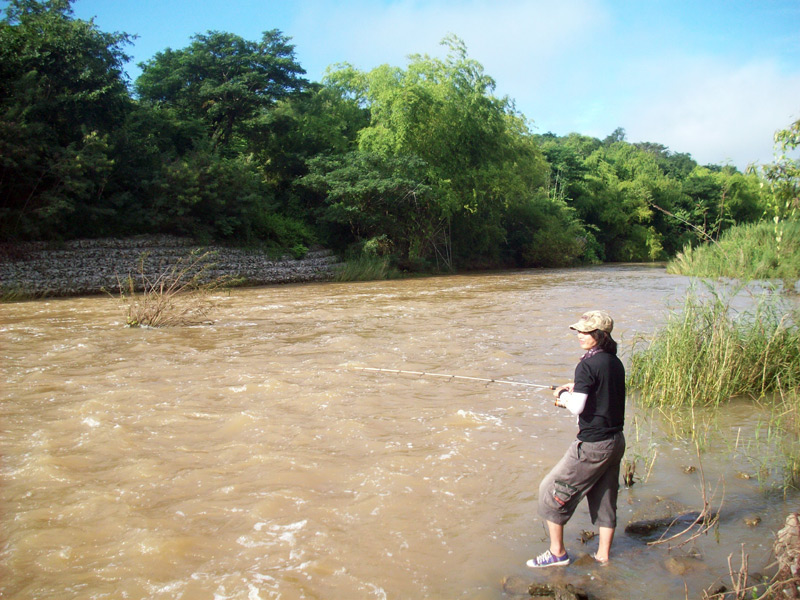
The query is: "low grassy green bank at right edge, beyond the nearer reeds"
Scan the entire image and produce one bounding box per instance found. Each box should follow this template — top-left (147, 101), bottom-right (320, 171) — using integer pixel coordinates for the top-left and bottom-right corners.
top-left (667, 221), bottom-right (800, 287)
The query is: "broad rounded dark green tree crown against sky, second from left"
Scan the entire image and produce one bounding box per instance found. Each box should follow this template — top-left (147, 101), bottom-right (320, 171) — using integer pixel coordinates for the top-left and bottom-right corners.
top-left (136, 29), bottom-right (308, 148)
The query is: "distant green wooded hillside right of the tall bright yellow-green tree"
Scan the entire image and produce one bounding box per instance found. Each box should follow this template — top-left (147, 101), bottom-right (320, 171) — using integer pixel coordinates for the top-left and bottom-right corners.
top-left (538, 130), bottom-right (766, 261)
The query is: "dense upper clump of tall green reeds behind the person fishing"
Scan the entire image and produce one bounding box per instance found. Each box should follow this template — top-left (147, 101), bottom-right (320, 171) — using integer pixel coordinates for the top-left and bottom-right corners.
top-left (630, 290), bottom-right (800, 409)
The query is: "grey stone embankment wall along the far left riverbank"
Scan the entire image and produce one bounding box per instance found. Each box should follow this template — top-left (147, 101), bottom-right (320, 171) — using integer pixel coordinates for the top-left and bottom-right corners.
top-left (0, 236), bottom-right (338, 296)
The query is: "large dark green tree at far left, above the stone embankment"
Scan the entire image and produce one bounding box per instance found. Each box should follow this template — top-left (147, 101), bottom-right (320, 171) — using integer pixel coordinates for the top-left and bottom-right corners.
top-left (0, 0), bottom-right (131, 238)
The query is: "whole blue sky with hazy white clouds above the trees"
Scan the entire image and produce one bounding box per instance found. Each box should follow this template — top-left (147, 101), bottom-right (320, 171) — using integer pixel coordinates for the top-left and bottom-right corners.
top-left (43, 0), bottom-right (800, 169)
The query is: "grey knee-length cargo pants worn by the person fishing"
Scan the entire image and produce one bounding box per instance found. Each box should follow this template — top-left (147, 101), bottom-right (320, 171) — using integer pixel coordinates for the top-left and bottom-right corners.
top-left (539, 432), bottom-right (625, 528)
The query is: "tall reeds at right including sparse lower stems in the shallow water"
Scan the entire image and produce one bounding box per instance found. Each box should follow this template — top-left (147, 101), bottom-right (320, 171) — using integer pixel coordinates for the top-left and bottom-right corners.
top-left (629, 288), bottom-right (800, 492)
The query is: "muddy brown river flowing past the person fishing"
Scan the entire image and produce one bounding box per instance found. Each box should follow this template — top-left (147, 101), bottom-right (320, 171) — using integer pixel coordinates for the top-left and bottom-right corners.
top-left (0, 265), bottom-right (797, 600)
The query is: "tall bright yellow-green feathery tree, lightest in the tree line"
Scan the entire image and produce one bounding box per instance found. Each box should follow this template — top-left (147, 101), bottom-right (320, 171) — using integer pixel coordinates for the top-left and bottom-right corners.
top-left (318, 36), bottom-right (547, 264)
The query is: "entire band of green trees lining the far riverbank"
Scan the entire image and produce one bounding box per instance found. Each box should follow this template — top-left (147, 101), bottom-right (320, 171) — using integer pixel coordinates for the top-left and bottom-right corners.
top-left (0, 0), bottom-right (780, 270)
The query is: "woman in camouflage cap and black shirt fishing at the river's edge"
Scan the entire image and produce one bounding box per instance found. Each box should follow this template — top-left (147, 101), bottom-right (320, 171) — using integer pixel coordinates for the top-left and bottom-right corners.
top-left (527, 310), bottom-right (625, 568)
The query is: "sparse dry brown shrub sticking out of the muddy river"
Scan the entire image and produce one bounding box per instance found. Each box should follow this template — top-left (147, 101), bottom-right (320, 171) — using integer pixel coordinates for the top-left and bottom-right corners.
top-left (119, 251), bottom-right (236, 327)
